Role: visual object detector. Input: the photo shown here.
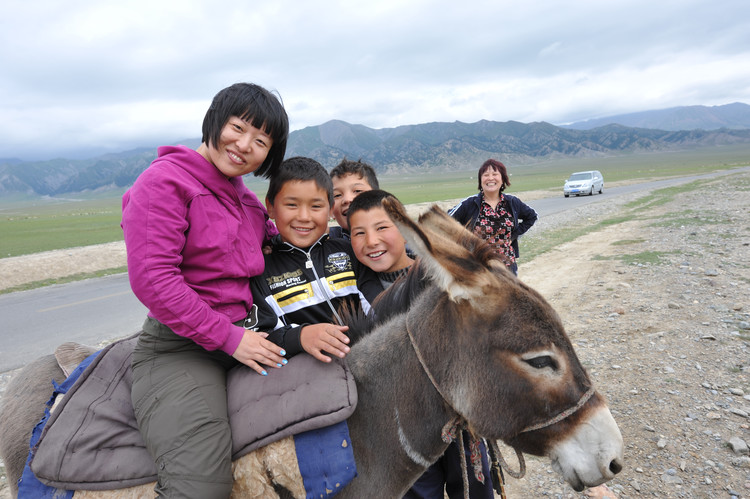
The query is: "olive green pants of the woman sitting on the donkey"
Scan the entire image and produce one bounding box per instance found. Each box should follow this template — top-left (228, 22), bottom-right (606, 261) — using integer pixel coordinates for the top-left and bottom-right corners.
top-left (131, 318), bottom-right (238, 499)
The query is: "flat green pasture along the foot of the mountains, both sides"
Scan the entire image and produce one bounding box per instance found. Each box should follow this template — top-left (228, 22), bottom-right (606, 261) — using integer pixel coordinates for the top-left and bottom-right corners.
top-left (0, 144), bottom-right (750, 258)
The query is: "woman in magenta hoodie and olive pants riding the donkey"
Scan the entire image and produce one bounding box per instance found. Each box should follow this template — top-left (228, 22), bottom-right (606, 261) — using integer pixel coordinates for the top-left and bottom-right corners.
top-left (122, 83), bottom-right (289, 498)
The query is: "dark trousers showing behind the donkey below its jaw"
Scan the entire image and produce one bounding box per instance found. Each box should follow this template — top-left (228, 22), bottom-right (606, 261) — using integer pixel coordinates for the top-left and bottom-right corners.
top-left (404, 432), bottom-right (495, 499)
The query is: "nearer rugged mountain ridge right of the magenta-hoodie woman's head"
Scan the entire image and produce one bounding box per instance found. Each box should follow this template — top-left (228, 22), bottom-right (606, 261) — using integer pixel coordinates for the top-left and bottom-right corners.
top-left (287, 120), bottom-right (750, 173)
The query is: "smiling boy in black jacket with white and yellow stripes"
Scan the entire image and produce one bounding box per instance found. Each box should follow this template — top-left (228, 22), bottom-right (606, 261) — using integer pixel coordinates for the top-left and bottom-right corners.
top-left (246, 157), bottom-right (383, 362)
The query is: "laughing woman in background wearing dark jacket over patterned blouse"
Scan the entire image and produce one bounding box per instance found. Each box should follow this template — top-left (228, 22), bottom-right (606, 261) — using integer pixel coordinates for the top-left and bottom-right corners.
top-left (448, 159), bottom-right (537, 274)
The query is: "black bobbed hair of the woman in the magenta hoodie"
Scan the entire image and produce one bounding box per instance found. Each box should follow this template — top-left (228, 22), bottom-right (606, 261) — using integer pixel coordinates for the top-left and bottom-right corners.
top-left (202, 83), bottom-right (289, 178)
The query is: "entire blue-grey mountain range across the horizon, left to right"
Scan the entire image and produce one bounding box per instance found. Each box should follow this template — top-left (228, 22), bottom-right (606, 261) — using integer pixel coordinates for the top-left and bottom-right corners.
top-left (0, 103), bottom-right (750, 197)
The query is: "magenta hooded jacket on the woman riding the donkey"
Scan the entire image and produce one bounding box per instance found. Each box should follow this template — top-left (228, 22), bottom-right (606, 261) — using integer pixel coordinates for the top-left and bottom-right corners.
top-left (122, 146), bottom-right (278, 355)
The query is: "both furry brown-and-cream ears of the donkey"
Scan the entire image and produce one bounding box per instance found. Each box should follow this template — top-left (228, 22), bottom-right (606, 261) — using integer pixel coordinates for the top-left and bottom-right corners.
top-left (383, 199), bottom-right (494, 301)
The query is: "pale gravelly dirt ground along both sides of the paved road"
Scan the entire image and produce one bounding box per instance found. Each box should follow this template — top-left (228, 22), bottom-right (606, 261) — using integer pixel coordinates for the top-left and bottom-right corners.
top-left (0, 174), bottom-right (750, 499)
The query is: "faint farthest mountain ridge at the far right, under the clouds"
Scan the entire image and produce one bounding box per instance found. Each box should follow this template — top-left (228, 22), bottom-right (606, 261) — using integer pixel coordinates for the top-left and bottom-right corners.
top-left (563, 102), bottom-right (750, 131)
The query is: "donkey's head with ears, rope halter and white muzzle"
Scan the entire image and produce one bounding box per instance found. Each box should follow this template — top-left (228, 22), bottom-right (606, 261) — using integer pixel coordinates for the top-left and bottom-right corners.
top-left (383, 200), bottom-right (623, 490)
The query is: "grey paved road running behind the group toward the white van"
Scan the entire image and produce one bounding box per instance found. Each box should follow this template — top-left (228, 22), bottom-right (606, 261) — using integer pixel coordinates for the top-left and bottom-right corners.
top-left (0, 167), bottom-right (750, 372)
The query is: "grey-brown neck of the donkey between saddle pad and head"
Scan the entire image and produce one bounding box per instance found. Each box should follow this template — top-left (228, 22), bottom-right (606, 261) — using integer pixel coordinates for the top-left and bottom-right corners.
top-left (345, 315), bottom-right (456, 497)
